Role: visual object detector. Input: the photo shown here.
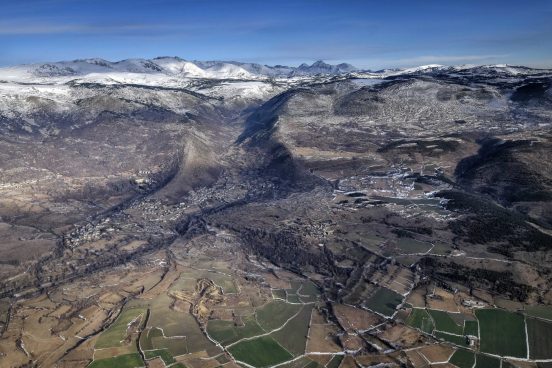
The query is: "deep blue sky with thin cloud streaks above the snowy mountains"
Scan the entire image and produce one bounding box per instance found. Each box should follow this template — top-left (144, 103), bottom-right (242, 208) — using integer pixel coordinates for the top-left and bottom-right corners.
top-left (0, 0), bottom-right (552, 69)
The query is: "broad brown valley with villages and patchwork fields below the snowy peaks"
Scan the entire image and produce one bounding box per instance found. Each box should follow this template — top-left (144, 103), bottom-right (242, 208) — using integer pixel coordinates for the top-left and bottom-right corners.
top-left (0, 61), bottom-right (552, 368)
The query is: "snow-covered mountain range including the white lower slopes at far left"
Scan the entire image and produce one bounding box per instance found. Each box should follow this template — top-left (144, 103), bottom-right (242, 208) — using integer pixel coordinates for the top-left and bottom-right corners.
top-left (0, 57), bottom-right (552, 119)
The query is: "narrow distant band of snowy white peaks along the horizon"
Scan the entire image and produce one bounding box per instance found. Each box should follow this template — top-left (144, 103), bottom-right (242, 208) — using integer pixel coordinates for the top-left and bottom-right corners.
top-left (0, 56), bottom-right (550, 86)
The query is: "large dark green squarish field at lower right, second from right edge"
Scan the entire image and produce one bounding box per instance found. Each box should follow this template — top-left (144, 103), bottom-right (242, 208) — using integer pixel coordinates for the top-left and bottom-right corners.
top-left (475, 309), bottom-right (527, 358)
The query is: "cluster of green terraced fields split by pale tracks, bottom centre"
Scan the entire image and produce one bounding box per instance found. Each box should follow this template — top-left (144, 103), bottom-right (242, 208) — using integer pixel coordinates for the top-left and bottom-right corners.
top-left (206, 279), bottom-right (332, 368)
